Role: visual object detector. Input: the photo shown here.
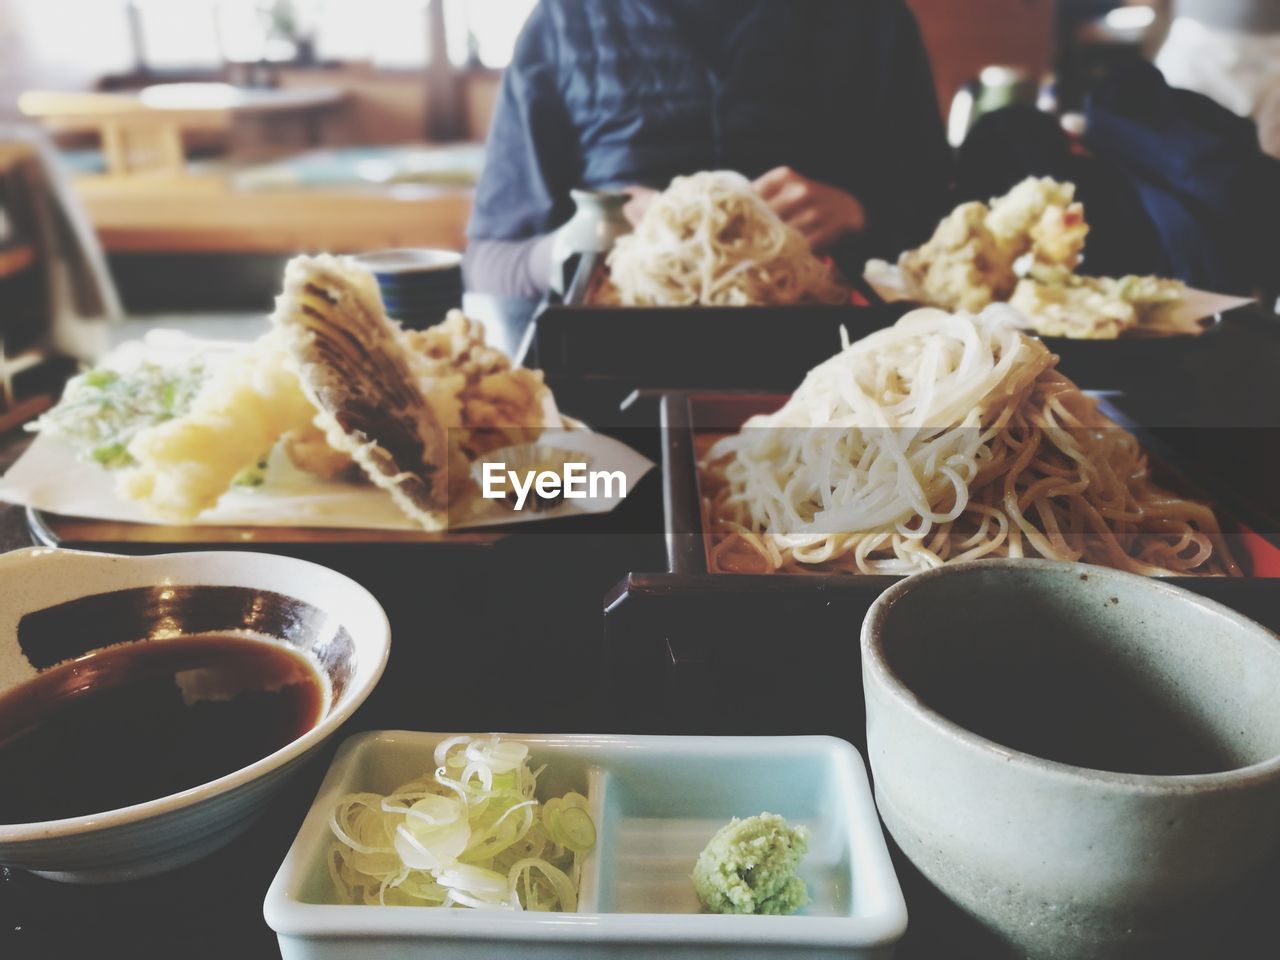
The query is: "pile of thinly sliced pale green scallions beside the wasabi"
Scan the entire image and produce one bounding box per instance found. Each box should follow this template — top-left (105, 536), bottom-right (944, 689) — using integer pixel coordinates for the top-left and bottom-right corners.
top-left (329, 736), bottom-right (595, 911)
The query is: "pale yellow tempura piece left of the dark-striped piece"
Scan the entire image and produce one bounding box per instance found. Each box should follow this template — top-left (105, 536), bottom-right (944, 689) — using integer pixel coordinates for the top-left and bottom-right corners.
top-left (116, 334), bottom-right (315, 522)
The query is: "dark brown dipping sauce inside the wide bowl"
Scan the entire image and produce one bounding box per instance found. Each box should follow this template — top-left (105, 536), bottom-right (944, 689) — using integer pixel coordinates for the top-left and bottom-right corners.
top-left (0, 635), bottom-right (325, 823)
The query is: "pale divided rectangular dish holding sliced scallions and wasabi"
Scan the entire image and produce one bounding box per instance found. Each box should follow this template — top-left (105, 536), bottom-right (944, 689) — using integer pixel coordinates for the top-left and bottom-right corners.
top-left (264, 732), bottom-right (906, 960)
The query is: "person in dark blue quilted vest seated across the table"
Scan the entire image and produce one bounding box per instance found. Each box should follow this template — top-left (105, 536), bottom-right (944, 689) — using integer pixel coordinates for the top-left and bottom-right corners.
top-left (465, 0), bottom-right (951, 297)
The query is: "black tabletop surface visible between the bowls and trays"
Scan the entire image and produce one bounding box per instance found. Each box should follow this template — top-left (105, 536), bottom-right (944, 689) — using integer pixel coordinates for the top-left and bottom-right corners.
top-left (0, 302), bottom-right (1280, 960)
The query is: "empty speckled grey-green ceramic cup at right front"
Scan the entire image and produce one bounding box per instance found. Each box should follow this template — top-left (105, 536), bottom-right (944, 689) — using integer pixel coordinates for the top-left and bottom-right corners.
top-left (861, 561), bottom-right (1280, 960)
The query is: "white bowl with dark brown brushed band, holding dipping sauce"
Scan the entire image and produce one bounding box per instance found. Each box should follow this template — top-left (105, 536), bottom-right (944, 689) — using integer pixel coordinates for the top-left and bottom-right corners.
top-left (0, 548), bottom-right (390, 883)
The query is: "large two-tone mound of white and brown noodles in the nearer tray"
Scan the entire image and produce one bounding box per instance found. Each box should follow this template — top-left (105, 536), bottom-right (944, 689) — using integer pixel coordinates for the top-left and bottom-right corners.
top-left (700, 307), bottom-right (1240, 575)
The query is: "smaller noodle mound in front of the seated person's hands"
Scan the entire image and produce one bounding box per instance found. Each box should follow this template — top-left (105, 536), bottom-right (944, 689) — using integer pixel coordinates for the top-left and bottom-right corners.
top-left (604, 170), bottom-right (849, 306)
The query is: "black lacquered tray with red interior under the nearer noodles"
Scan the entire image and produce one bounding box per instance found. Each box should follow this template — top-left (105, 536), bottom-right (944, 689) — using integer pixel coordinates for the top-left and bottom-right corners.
top-left (599, 392), bottom-right (1280, 744)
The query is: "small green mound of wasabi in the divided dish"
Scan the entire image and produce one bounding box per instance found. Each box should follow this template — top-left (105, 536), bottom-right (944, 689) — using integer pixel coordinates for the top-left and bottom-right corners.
top-left (692, 813), bottom-right (809, 914)
